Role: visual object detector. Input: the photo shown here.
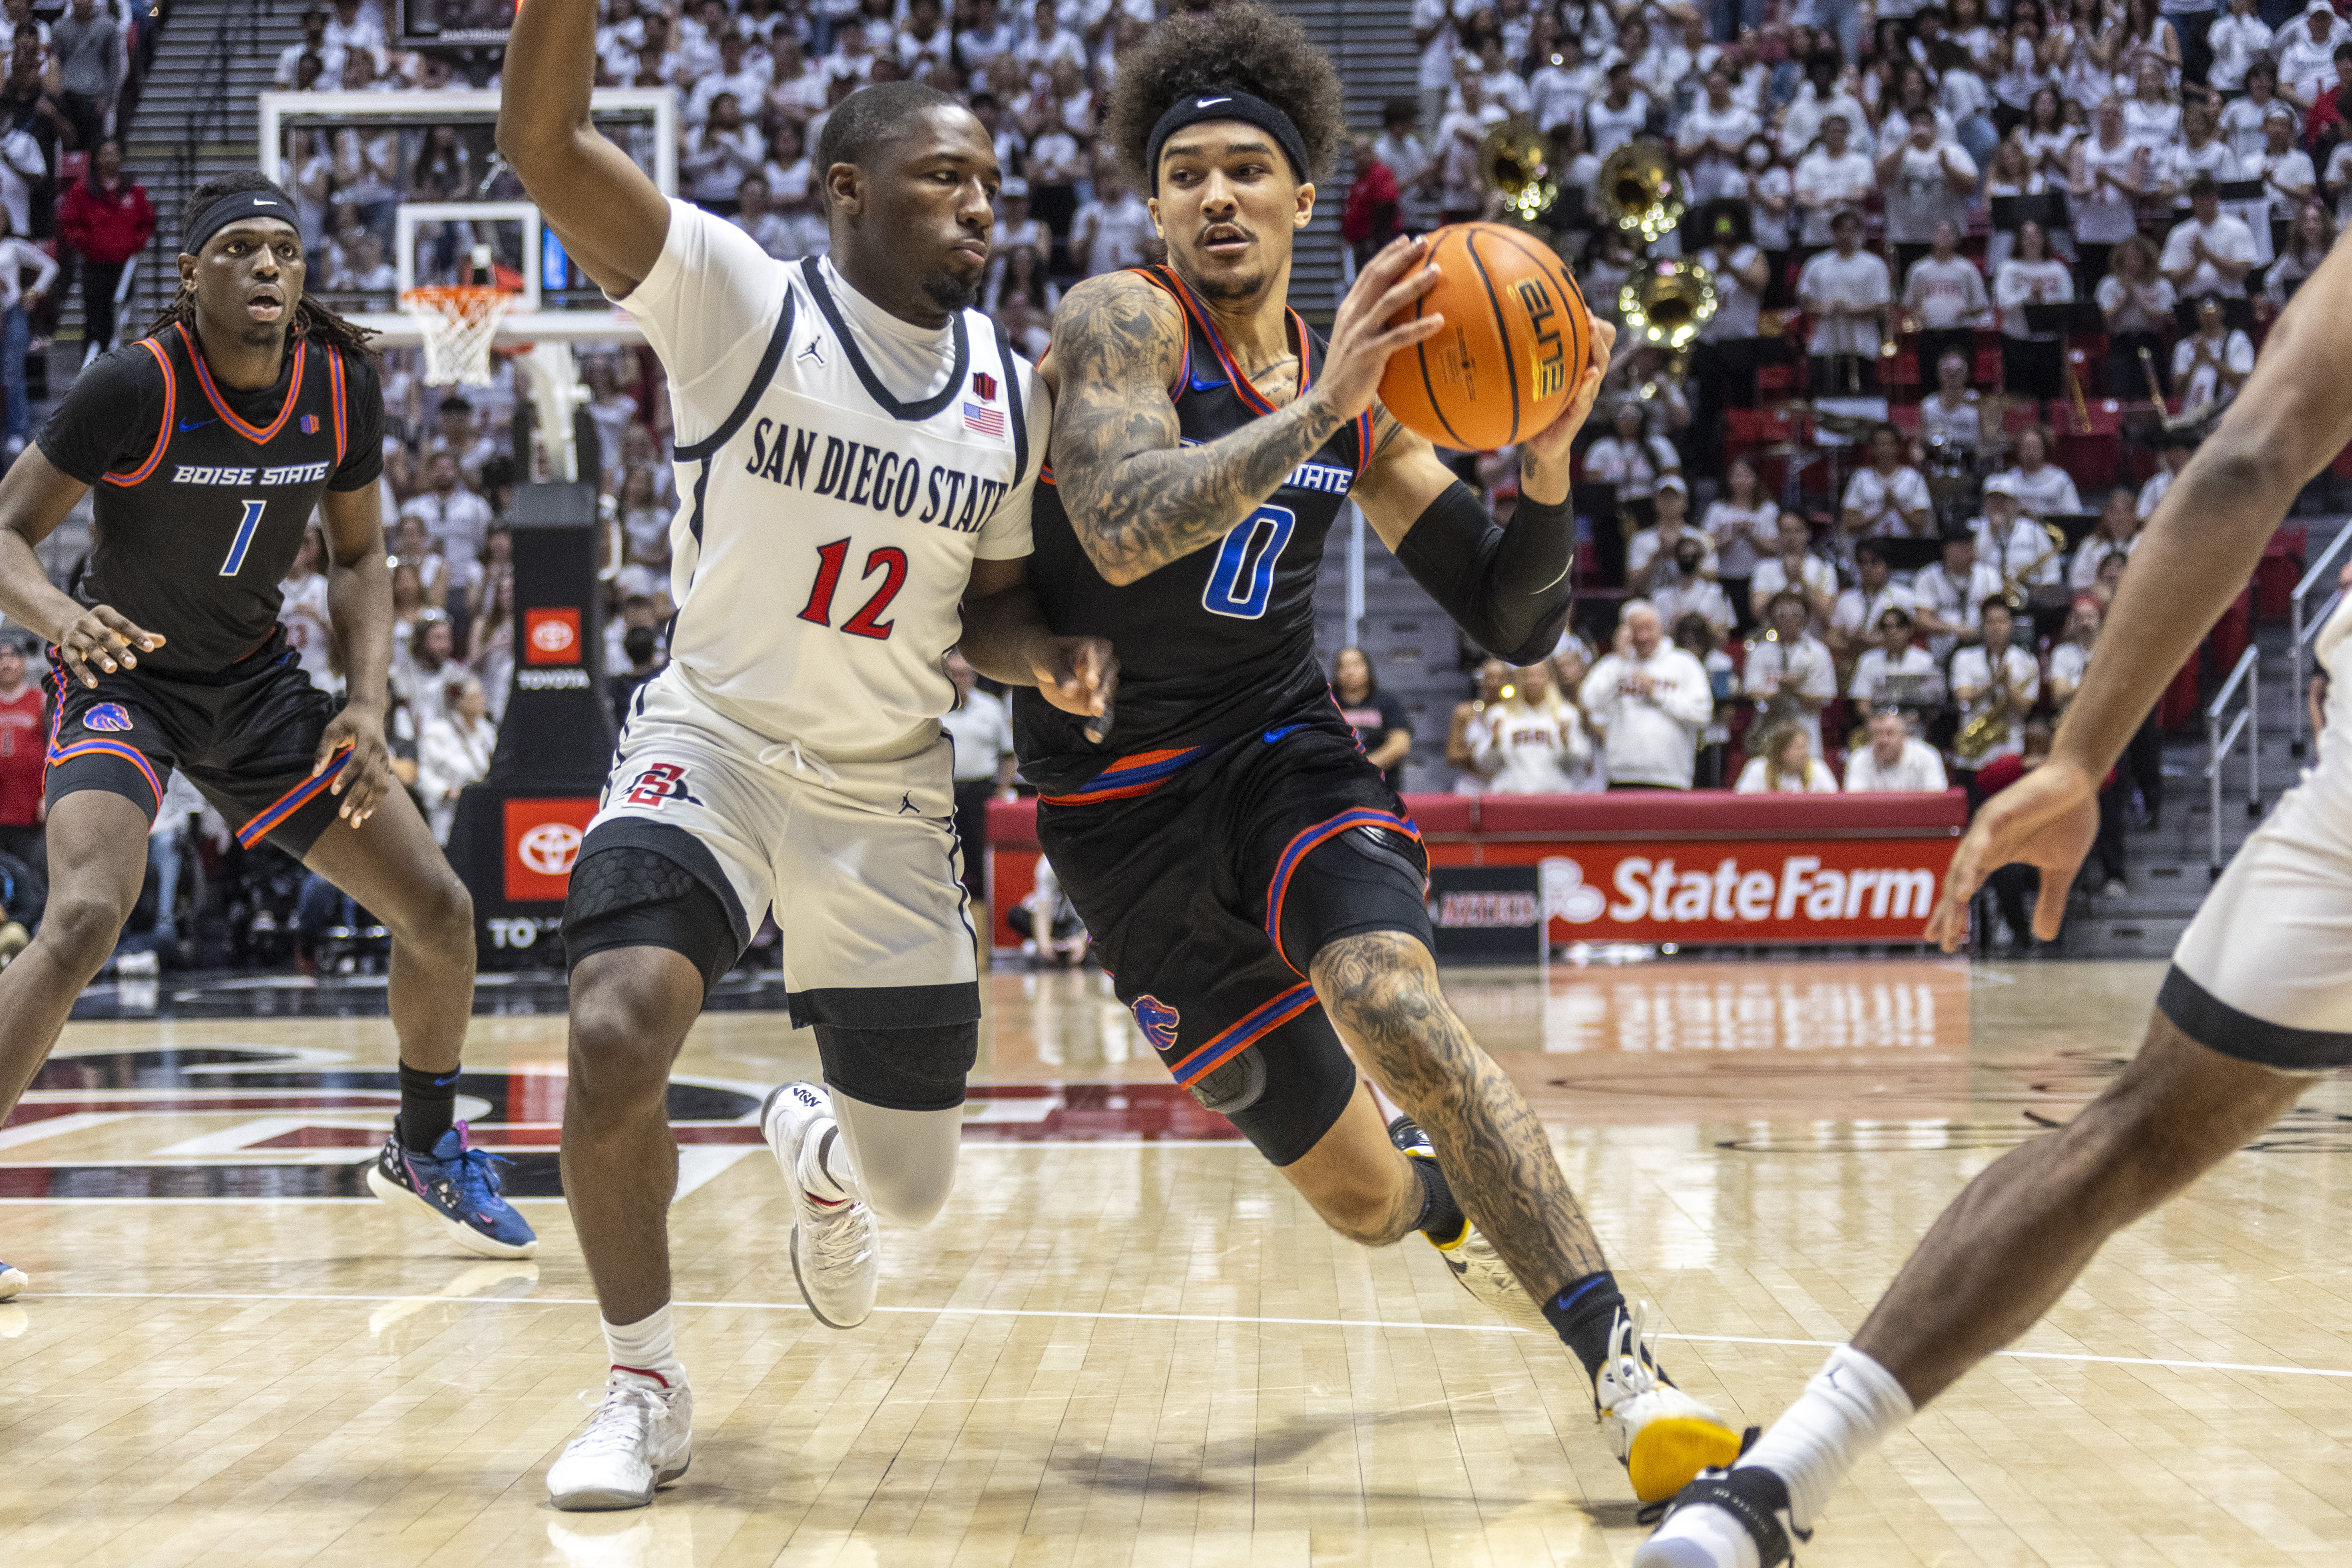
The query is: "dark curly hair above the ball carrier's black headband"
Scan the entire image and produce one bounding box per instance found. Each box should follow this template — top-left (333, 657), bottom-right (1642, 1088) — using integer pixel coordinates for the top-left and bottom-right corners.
top-left (1103, 2), bottom-right (1346, 191)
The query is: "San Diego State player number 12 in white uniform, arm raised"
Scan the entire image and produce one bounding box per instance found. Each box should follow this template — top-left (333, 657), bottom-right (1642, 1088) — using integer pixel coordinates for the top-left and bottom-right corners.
top-left (499, 0), bottom-right (1115, 1509)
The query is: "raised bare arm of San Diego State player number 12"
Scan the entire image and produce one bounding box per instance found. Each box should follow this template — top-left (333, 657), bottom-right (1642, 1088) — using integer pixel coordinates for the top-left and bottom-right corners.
top-left (499, 0), bottom-right (670, 299)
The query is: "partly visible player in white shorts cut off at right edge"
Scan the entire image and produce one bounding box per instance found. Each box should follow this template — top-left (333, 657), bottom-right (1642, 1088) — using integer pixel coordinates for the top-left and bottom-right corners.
top-left (1635, 227), bottom-right (2352, 1568)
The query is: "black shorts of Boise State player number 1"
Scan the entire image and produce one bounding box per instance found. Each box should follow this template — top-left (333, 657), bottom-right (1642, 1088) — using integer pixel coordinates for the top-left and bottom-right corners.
top-left (47, 632), bottom-right (350, 860)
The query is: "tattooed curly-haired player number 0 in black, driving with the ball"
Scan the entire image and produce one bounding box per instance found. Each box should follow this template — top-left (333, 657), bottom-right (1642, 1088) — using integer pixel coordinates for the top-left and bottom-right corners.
top-left (1014, 5), bottom-right (1738, 1500)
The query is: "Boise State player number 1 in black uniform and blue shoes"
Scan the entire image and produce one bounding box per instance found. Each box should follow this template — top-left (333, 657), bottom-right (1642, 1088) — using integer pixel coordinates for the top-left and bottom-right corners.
top-left (0, 174), bottom-right (538, 1316)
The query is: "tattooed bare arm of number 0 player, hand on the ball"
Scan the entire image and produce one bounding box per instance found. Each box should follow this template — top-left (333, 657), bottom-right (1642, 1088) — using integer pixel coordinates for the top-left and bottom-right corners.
top-left (1049, 240), bottom-right (1444, 585)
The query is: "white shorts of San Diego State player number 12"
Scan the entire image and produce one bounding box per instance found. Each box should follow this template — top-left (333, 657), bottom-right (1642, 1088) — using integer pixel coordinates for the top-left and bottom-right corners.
top-left (574, 668), bottom-right (981, 1030)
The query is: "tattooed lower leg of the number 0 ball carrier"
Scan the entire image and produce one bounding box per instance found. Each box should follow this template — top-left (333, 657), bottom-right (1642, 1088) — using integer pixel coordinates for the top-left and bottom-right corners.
top-left (1310, 931), bottom-right (1609, 1302)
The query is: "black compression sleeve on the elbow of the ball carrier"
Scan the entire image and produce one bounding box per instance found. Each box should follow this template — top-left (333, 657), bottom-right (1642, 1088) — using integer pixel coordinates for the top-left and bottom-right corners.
top-left (1397, 480), bottom-right (1576, 665)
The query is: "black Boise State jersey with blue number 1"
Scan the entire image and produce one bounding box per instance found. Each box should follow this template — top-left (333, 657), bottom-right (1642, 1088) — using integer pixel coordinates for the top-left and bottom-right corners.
top-left (40, 322), bottom-right (384, 679)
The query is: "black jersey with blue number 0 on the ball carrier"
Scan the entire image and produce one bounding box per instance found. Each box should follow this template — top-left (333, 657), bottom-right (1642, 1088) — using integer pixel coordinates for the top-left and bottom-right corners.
top-left (1014, 266), bottom-right (1371, 804)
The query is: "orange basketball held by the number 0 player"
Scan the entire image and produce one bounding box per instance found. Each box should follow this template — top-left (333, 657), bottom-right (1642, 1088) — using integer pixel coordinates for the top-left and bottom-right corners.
top-left (1381, 223), bottom-right (1592, 452)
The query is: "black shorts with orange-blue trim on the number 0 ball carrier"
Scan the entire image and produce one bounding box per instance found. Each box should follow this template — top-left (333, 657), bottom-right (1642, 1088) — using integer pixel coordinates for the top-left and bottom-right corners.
top-left (1037, 712), bottom-right (1430, 1166)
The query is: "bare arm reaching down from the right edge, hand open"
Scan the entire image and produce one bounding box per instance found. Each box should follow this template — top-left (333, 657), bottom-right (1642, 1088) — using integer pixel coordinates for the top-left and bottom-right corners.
top-left (1929, 223), bottom-right (2352, 952)
